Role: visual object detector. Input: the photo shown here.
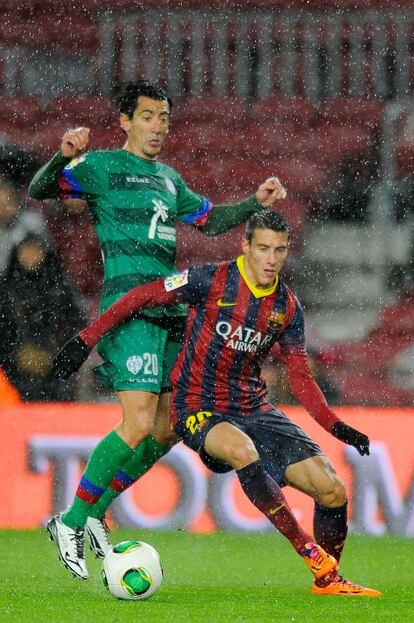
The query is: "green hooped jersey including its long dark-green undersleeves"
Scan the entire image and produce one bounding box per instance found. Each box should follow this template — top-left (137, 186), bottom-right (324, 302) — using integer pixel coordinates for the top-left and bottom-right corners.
top-left (29, 149), bottom-right (261, 316)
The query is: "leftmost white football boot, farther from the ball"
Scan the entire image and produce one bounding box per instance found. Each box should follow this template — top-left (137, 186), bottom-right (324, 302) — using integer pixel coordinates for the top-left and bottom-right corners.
top-left (46, 515), bottom-right (89, 580)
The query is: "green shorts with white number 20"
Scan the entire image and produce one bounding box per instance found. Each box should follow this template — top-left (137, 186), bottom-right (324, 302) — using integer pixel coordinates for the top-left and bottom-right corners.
top-left (94, 317), bottom-right (185, 394)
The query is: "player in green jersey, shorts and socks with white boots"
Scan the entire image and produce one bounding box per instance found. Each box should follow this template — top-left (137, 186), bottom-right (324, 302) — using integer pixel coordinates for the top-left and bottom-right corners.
top-left (29, 80), bottom-right (286, 579)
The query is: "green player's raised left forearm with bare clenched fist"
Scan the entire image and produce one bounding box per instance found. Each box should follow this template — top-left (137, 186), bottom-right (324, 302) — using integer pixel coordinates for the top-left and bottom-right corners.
top-left (29, 128), bottom-right (90, 199)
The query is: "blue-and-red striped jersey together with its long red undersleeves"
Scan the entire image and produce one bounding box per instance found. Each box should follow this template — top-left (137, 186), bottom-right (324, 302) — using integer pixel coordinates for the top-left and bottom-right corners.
top-left (79, 256), bottom-right (340, 431)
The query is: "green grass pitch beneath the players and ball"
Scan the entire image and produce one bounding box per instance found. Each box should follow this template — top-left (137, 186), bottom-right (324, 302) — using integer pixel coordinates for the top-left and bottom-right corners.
top-left (0, 530), bottom-right (414, 623)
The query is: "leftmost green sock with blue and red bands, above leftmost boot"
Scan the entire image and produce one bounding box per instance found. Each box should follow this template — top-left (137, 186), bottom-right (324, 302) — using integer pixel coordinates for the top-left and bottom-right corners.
top-left (62, 431), bottom-right (134, 529)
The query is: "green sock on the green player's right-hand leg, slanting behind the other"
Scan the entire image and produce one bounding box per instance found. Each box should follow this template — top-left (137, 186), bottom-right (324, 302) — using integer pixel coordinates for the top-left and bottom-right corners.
top-left (89, 435), bottom-right (169, 519)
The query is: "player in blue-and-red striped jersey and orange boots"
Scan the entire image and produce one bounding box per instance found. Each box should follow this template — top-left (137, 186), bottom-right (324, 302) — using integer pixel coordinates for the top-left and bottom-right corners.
top-left (55, 210), bottom-right (380, 596)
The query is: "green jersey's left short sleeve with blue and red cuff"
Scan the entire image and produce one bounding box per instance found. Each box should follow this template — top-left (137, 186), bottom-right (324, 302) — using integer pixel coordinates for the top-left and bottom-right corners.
top-left (58, 154), bottom-right (102, 201)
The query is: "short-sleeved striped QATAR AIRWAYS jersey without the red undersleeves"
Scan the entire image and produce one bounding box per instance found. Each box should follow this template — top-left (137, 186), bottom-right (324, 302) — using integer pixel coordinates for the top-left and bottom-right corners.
top-left (171, 257), bottom-right (305, 420)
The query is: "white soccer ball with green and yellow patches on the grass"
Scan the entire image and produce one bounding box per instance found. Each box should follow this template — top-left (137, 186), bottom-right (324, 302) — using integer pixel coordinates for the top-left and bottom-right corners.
top-left (102, 541), bottom-right (164, 600)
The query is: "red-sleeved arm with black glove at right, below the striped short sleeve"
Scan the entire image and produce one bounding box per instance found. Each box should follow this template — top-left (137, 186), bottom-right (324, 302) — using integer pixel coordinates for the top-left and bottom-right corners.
top-left (284, 353), bottom-right (369, 456)
